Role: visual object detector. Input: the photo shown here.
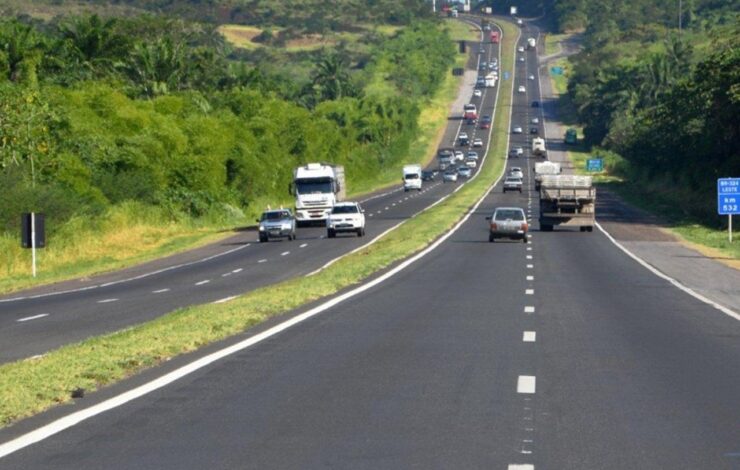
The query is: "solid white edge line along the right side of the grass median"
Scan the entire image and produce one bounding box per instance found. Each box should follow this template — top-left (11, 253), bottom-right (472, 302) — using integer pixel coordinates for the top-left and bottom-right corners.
top-left (0, 19), bottom-right (511, 458)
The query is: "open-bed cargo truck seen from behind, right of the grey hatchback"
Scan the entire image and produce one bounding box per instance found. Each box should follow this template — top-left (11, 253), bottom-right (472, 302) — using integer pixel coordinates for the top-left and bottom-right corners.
top-left (539, 175), bottom-right (596, 232)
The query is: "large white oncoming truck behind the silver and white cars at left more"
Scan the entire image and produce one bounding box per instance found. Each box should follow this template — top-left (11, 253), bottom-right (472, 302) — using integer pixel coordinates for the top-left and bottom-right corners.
top-left (291, 163), bottom-right (346, 223)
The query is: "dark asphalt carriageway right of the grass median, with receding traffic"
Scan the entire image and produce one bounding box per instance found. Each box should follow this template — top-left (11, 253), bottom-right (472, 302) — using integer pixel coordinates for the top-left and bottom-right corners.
top-left (0, 16), bottom-right (740, 470)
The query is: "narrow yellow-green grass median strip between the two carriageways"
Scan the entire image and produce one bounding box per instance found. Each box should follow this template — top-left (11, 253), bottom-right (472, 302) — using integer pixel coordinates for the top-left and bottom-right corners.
top-left (0, 23), bottom-right (516, 426)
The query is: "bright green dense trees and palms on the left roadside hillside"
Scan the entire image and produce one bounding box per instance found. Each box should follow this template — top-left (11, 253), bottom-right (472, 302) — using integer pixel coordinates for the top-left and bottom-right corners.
top-left (0, 1), bottom-right (455, 239)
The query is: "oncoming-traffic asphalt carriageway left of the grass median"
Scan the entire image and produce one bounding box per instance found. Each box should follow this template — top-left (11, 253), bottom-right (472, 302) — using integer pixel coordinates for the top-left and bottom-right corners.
top-left (0, 23), bottom-right (499, 363)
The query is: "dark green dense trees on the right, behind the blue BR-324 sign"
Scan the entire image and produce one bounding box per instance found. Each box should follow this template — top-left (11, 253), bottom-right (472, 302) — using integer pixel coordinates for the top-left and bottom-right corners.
top-left (554, 0), bottom-right (740, 221)
